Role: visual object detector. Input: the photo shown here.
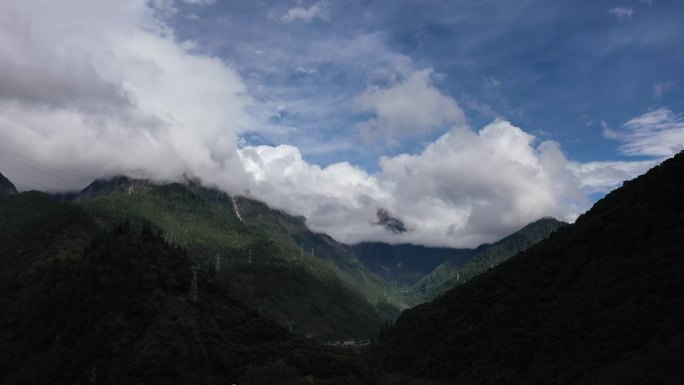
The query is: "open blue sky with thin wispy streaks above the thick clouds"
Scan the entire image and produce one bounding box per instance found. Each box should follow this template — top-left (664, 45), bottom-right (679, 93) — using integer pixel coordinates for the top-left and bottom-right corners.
top-left (171, 0), bottom-right (684, 165)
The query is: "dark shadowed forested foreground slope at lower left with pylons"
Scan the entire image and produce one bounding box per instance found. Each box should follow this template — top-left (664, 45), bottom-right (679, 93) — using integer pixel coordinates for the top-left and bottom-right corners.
top-left (0, 193), bottom-right (379, 384)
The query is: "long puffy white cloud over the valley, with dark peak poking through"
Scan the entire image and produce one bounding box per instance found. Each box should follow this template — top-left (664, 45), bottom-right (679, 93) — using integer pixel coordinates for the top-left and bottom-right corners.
top-left (240, 120), bottom-right (600, 246)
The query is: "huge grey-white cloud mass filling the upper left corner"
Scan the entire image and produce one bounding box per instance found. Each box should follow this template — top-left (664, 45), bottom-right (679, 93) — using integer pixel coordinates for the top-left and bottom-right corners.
top-left (0, 0), bottom-right (252, 190)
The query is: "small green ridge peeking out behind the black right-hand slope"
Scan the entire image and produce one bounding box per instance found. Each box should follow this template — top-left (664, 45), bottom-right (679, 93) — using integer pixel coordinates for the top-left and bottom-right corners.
top-left (414, 217), bottom-right (567, 299)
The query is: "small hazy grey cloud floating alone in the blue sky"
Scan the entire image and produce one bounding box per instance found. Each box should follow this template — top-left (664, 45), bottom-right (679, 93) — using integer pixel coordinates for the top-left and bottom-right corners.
top-left (356, 69), bottom-right (465, 141)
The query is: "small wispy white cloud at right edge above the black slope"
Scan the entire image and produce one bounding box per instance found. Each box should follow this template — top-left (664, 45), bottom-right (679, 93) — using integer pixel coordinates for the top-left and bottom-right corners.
top-left (604, 107), bottom-right (684, 158)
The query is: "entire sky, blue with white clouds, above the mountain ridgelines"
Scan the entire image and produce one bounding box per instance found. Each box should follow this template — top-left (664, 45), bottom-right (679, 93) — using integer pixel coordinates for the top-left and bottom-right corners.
top-left (0, 0), bottom-right (684, 247)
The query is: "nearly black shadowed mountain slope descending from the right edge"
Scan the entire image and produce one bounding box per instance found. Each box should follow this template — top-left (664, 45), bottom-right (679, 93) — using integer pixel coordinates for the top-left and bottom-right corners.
top-left (377, 153), bottom-right (684, 384)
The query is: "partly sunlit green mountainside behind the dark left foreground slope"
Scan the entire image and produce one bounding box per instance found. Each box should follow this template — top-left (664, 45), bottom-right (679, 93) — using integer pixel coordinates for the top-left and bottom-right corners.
top-left (77, 178), bottom-right (401, 340)
